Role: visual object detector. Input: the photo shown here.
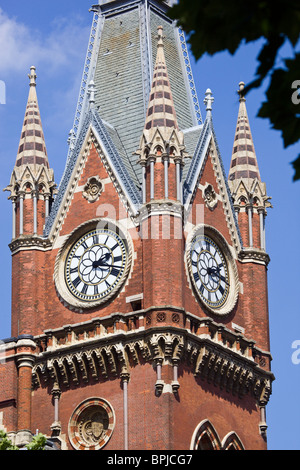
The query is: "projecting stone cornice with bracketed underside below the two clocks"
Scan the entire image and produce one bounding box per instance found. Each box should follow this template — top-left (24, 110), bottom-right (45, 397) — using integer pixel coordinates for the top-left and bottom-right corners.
top-left (33, 308), bottom-right (274, 404)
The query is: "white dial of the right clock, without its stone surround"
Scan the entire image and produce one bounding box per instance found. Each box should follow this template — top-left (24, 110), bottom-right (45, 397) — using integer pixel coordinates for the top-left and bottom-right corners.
top-left (190, 234), bottom-right (230, 310)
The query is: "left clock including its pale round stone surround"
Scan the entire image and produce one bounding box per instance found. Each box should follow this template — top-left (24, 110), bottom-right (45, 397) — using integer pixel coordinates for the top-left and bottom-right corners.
top-left (55, 223), bottom-right (130, 308)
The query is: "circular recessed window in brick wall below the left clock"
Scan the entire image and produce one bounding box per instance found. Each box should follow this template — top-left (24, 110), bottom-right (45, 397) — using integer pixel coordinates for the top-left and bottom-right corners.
top-left (69, 398), bottom-right (115, 450)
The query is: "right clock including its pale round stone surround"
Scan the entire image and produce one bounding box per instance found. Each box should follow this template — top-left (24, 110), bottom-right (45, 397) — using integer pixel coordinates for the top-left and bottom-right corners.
top-left (187, 227), bottom-right (238, 314)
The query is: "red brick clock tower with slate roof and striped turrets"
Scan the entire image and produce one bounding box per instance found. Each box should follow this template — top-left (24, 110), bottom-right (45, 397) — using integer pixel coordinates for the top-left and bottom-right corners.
top-left (0, 0), bottom-right (274, 451)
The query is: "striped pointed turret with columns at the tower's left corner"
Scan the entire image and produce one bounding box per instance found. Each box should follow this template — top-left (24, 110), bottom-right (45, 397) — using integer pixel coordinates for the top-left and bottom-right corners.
top-left (5, 66), bottom-right (56, 239)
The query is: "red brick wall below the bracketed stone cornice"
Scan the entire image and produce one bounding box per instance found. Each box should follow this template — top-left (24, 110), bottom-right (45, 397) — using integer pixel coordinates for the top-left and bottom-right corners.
top-left (32, 364), bottom-right (265, 450)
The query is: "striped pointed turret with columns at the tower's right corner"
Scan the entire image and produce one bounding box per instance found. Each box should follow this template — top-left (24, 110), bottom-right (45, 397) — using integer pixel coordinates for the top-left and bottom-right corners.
top-left (228, 82), bottom-right (272, 251)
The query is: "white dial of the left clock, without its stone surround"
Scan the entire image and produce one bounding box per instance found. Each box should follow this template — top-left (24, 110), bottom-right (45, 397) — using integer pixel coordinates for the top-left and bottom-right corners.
top-left (65, 228), bottom-right (128, 304)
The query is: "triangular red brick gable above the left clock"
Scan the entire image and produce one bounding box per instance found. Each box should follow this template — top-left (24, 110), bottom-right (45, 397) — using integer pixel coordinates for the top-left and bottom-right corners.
top-left (45, 113), bottom-right (140, 242)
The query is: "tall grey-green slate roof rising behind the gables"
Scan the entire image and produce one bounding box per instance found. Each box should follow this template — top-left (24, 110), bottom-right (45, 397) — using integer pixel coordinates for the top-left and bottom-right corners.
top-left (45, 0), bottom-right (203, 236)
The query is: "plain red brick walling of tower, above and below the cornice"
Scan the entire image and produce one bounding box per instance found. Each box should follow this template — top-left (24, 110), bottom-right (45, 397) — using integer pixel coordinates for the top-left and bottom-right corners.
top-left (8, 141), bottom-right (269, 449)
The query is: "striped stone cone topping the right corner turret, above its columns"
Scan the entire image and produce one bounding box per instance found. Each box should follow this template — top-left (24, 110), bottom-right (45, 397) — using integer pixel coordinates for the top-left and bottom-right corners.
top-left (228, 82), bottom-right (260, 181)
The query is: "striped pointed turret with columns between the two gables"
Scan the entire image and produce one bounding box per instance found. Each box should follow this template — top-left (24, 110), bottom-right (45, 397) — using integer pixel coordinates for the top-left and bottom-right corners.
top-left (136, 26), bottom-right (187, 203)
